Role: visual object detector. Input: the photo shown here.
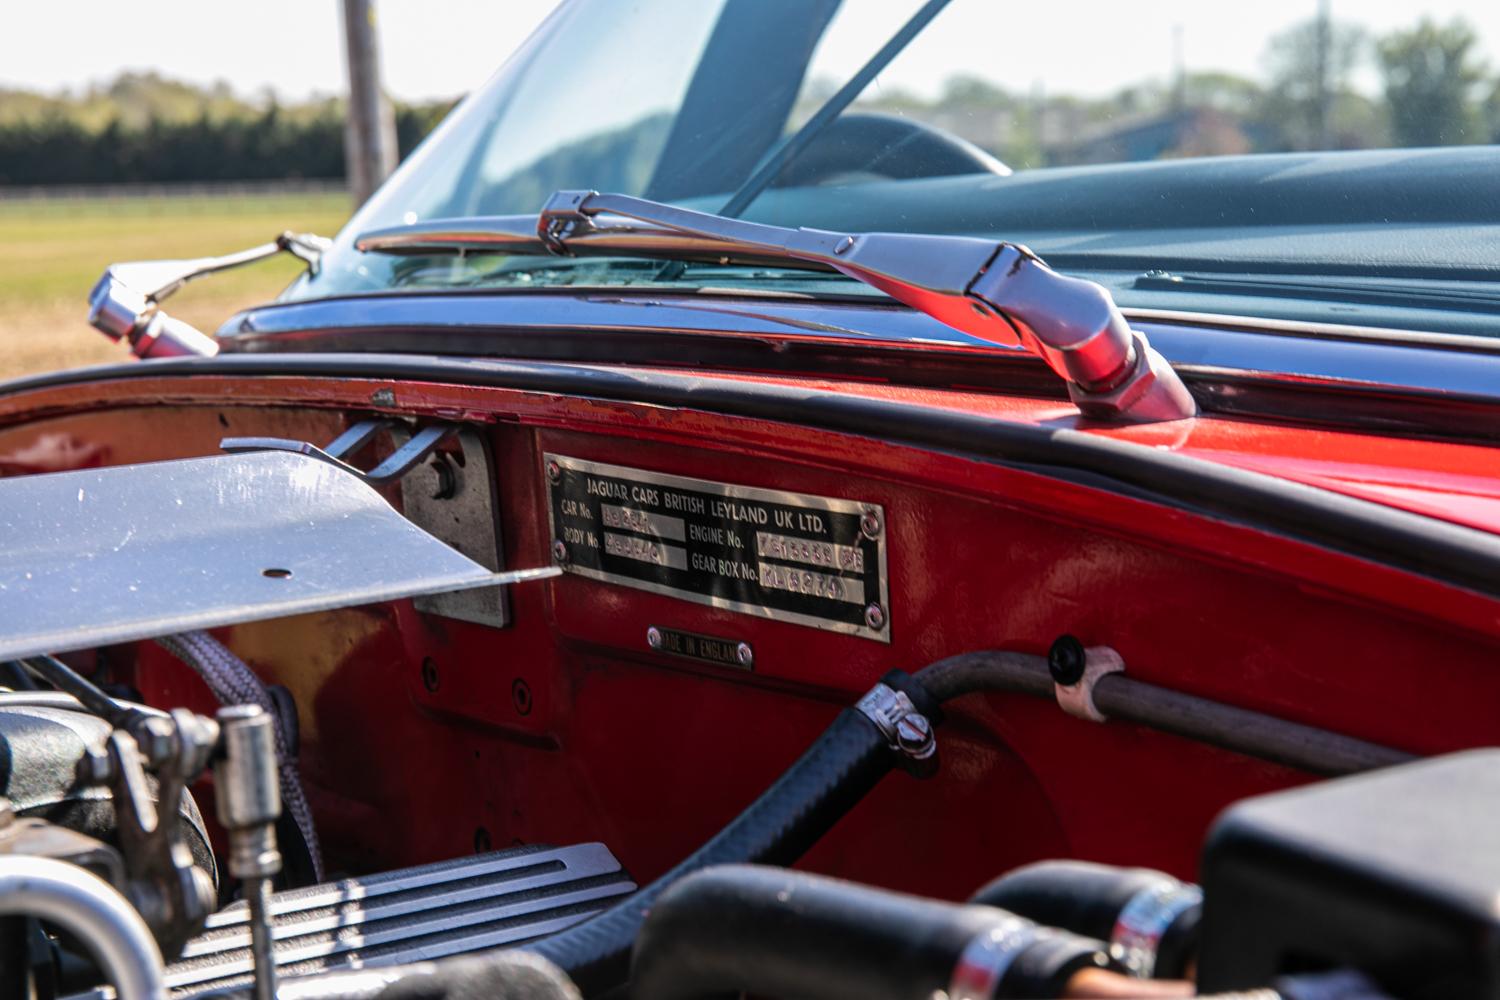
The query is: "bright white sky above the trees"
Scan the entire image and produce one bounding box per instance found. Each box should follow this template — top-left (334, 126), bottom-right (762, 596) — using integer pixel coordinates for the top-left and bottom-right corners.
top-left (0, 0), bottom-right (1500, 100)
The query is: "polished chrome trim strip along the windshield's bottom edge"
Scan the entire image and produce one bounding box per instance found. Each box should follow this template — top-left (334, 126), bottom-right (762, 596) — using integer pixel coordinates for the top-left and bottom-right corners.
top-left (219, 292), bottom-right (1500, 402)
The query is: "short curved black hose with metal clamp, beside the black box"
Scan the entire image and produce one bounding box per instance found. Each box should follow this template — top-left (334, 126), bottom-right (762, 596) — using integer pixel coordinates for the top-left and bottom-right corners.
top-left (969, 861), bottom-right (1203, 979)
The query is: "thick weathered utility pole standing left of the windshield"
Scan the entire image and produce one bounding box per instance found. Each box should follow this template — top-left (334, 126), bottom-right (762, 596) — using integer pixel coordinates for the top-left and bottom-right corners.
top-left (344, 0), bottom-right (396, 208)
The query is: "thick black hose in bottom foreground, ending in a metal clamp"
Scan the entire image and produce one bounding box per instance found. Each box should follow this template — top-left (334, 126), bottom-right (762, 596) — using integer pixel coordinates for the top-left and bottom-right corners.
top-left (630, 865), bottom-right (1106, 1000)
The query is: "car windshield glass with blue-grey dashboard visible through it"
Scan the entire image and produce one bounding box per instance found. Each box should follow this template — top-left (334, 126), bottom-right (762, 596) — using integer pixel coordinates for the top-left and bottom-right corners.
top-left (285, 0), bottom-right (1500, 335)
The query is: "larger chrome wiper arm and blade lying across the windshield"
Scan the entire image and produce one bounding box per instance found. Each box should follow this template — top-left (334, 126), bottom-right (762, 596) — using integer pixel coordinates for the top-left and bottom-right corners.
top-left (354, 190), bottom-right (1197, 423)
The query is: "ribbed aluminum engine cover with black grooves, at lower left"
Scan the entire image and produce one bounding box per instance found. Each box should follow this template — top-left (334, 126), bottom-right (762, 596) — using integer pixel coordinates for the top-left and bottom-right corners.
top-left (167, 844), bottom-right (636, 997)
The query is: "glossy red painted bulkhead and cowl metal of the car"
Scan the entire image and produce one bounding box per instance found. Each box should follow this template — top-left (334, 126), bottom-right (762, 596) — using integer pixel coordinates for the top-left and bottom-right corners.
top-left (0, 370), bottom-right (1500, 895)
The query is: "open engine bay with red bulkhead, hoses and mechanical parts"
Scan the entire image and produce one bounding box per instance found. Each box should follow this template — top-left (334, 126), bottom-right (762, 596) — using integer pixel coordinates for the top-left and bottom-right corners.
top-left (0, 376), bottom-right (1496, 999)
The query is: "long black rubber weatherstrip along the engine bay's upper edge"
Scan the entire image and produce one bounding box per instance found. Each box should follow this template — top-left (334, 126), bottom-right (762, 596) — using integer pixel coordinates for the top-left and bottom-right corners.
top-left (0, 354), bottom-right (1500, 597)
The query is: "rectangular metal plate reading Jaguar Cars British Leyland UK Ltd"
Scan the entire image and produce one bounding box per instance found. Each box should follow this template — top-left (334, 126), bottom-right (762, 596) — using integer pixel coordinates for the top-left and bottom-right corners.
top-left (543, 454), bottom-right (891, 642)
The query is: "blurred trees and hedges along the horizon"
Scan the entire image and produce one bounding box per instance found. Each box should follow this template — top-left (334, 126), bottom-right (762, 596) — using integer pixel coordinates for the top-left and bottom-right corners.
top-left (0, 18), bottom-right (1500, 186)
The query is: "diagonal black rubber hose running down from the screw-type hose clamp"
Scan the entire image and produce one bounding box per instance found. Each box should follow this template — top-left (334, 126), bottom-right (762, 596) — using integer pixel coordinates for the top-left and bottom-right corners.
top-left (524, 709), bottom-right (897, 997)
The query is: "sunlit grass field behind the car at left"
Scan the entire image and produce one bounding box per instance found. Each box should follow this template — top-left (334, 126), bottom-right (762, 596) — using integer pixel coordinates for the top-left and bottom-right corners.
top-left (0, 195), bottom-right (350, 378)
